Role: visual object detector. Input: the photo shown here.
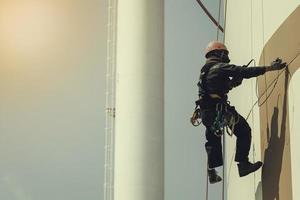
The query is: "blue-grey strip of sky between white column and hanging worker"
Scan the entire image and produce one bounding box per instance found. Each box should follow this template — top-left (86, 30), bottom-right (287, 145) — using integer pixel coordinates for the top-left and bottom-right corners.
top-left (164, 0), bottom-right (222, 200)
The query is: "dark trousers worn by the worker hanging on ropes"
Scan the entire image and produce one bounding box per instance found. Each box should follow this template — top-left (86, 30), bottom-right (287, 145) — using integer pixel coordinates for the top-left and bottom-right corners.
top-left (201, 106), bottom-right (251, 168)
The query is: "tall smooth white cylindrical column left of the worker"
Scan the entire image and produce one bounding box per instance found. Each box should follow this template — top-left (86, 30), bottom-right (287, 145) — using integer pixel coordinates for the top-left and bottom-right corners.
top-left (114, 0), bottom-right (164, 200)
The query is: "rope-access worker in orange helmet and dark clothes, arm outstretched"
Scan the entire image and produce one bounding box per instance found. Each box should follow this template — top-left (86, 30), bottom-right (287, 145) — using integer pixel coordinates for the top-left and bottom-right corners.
top-left (197, 41), bottom-right (286, 183)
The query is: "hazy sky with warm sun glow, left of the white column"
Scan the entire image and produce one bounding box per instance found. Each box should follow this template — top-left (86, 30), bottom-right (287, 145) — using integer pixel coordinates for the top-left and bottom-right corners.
top-left (0, 0), bottom-right (107, 200)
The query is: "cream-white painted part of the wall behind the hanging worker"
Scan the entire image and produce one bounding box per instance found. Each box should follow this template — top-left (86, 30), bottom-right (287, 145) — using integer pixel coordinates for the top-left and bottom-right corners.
top-left (225, 0), bottom-right (300, 200)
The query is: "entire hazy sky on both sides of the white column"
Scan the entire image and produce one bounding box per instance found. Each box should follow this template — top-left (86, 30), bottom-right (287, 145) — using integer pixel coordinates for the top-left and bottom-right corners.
top-left (0, 0), bottom-right (221, 200)
